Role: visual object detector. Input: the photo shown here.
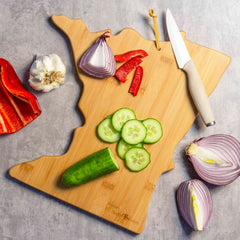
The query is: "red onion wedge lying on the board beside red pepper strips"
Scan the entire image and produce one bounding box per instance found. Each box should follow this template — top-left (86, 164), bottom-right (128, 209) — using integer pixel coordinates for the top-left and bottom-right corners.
top-left (79, 32), bottom-right (116, 78)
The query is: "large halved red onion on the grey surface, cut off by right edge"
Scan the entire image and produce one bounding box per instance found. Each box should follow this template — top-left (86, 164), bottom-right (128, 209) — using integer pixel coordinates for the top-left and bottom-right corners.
top-left (186, 134), bottom-right (240, 185)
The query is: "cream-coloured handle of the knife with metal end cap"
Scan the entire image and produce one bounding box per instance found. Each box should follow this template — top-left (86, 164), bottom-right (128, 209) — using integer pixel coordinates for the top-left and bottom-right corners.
top-left (183, 60), bottom-right (215, 127)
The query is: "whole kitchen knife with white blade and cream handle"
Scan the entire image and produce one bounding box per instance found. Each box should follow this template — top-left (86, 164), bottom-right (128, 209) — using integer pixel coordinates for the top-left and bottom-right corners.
top-left (166, 9), bottom-right (215, 127)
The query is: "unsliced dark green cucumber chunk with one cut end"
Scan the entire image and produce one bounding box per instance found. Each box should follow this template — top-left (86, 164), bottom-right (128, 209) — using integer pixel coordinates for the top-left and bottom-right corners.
top-left (62, 147), bottom-right (119, 187)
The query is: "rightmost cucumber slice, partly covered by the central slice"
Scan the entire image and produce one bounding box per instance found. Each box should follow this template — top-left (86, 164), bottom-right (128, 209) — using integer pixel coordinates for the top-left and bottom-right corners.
top-left (142, 118), bottom-right (163, 143)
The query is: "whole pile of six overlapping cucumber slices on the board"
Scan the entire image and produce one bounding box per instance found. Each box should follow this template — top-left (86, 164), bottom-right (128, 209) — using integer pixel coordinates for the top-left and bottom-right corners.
top-left (97, 108), bottom-right (163, 172)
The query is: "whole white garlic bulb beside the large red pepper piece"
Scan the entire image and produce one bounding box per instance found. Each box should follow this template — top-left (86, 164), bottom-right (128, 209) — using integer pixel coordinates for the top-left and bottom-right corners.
top-left (28, 54), bottom-right (66, 92)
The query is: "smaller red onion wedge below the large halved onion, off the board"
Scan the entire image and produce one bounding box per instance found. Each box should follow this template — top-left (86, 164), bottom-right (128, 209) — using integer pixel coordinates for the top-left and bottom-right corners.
top-left (177, 179), bottom-right (212, 231)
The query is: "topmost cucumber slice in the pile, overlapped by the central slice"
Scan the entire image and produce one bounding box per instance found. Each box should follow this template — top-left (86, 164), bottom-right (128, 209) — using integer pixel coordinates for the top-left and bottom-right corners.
top-left (112, 108), bottom-right (136, 132)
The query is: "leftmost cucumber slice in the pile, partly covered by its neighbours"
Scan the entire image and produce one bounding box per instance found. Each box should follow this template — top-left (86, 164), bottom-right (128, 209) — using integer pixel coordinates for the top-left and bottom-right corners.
top-left (97, 116), bottom-right (121, 143)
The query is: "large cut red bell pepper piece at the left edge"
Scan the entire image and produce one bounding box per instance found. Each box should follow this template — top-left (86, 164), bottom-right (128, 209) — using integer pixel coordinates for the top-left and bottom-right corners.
top-left (0, 58), bottom-right (41, 134)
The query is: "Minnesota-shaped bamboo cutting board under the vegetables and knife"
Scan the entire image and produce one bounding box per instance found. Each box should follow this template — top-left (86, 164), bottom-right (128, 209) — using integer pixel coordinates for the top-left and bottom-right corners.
top-left (9, 15), bottom-right (231, 233)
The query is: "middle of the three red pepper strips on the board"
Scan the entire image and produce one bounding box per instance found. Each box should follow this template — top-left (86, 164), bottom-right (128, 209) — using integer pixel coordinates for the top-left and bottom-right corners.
top-left (115, 57), bottom-right (142, 83)
